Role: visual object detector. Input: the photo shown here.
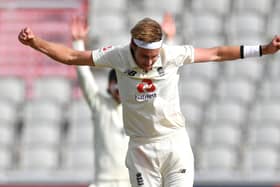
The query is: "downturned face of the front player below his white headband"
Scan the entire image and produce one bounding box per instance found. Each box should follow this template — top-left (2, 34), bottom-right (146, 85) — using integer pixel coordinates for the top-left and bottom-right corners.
top-left (134, 47), bottom-right (160, 72)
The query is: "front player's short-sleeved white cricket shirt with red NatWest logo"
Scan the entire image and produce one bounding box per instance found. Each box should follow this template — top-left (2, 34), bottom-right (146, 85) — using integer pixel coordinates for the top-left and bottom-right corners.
top-left (92, 45), bottom-right (194, 138)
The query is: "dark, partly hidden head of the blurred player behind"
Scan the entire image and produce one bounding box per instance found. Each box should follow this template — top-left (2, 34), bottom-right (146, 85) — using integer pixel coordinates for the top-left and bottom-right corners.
top-left (107, 69), bottom-right (121, 103)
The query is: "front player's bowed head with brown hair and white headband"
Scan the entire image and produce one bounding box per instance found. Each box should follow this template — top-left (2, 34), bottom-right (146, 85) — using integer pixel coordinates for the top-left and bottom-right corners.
top-left (130, 18), bottom-right (163, 71)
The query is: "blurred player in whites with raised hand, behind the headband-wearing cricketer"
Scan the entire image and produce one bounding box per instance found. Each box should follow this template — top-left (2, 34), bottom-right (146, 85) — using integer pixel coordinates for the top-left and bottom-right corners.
top-left (71, 17), bottom-right (131, 187)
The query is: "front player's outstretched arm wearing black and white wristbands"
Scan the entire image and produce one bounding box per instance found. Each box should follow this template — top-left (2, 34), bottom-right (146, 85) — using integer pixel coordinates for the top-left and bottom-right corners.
top-left (194, 36), bottom-right (280, 62)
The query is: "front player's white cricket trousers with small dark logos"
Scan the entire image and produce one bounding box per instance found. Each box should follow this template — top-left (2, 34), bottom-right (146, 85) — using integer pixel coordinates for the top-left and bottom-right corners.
top-left (126, 129), bottom-right (194, 187)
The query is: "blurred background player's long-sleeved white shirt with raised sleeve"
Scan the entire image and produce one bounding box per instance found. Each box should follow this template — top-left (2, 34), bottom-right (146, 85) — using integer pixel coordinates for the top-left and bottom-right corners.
top-left (74, 43), bottom-right (129, 181)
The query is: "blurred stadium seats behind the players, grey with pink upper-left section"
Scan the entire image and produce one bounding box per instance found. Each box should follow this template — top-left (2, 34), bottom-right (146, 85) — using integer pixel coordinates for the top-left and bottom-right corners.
top-left (0, 0), bottom-right (280, 187)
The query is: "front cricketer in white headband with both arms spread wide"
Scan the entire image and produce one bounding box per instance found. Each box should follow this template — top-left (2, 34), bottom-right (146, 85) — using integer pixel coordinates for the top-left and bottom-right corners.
top-left (18, 18), bottom-right (280, 187)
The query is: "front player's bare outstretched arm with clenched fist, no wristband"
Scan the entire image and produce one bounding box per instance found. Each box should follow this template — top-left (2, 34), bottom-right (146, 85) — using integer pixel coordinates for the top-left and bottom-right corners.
top-left (18, 27), bottom-right (94, 66)
